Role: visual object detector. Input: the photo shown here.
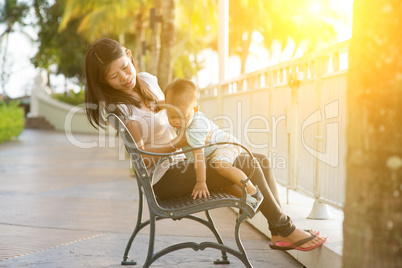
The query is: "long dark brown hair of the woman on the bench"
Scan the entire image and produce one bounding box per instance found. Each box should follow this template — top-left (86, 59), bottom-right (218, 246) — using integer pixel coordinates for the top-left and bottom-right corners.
top-left (85, 38), bottom-right (155, 129)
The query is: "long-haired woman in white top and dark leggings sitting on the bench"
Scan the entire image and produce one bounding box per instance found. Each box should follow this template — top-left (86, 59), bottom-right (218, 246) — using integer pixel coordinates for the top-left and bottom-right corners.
top-left (85, 38), bottom-right (327, 251)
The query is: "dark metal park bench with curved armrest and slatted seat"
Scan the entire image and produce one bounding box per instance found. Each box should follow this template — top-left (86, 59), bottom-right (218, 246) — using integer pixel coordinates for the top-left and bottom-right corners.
top-left (107, 113), bottom-right (258, 268)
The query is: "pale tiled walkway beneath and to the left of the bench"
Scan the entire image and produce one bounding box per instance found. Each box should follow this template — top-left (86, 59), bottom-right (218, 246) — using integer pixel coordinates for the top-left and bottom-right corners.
top-left (0, 130), bottom-right (301, 268)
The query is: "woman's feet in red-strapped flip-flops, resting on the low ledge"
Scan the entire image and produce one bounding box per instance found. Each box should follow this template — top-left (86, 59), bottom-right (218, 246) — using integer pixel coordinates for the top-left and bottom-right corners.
top-left (270, 228), bottom-right (328, 249)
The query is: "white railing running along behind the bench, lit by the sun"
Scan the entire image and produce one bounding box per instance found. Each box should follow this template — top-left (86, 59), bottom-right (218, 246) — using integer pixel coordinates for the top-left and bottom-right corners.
top-left (198, 41), bottom-right (349, 207)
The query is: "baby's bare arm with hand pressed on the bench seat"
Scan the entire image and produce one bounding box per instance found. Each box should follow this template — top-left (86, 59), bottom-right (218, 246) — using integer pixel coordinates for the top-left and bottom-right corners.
top-left (191, 149), bottom-right (209, 199)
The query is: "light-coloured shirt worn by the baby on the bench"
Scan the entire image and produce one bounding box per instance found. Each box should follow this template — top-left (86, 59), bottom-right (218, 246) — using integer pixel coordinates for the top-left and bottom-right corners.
top-left (176, 111), bottom-right (227, 162)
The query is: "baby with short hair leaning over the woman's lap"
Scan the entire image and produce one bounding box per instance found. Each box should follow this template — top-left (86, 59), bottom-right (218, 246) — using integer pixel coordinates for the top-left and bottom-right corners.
top-left (165, 78), bottom-right (263, 207)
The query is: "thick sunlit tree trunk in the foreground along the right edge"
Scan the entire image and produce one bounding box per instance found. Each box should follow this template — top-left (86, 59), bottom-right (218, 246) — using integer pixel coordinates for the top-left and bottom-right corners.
top-left (343, 0), bottom-right (402, 268)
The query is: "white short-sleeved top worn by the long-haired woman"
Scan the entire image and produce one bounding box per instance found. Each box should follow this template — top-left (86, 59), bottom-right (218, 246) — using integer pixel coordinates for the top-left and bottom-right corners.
top-left (121, 72), bottom-right (184, 184)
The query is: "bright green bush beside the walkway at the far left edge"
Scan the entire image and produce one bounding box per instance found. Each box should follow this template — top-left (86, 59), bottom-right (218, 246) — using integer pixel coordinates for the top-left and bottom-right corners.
top-left (0, 102), bottom-right (24, 143)
